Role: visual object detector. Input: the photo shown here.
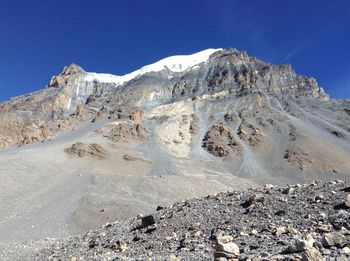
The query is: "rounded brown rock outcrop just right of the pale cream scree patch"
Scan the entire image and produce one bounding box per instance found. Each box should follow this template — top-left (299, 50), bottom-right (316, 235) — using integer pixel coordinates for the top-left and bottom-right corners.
top-left (202, 123), bottom-right (241, 157)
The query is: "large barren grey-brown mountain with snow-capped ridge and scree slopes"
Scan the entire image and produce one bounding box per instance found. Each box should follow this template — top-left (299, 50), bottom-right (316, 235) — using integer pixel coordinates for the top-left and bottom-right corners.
top-left (0, 49), bottom-right (350, 256)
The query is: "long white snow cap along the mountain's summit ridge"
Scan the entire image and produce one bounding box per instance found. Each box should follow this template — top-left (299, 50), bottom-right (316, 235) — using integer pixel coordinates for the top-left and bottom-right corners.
top-left (83, 49), bottom-right (222, 86)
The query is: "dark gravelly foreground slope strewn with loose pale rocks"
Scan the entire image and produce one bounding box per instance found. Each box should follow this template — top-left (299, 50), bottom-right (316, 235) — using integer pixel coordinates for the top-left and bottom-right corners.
top-left (17, 181), bottom-right (350, 260)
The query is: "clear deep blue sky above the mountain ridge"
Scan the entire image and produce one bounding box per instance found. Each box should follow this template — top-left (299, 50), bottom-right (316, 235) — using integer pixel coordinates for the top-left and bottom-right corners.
top-left (0, 0), bottom-right (350, 100)
